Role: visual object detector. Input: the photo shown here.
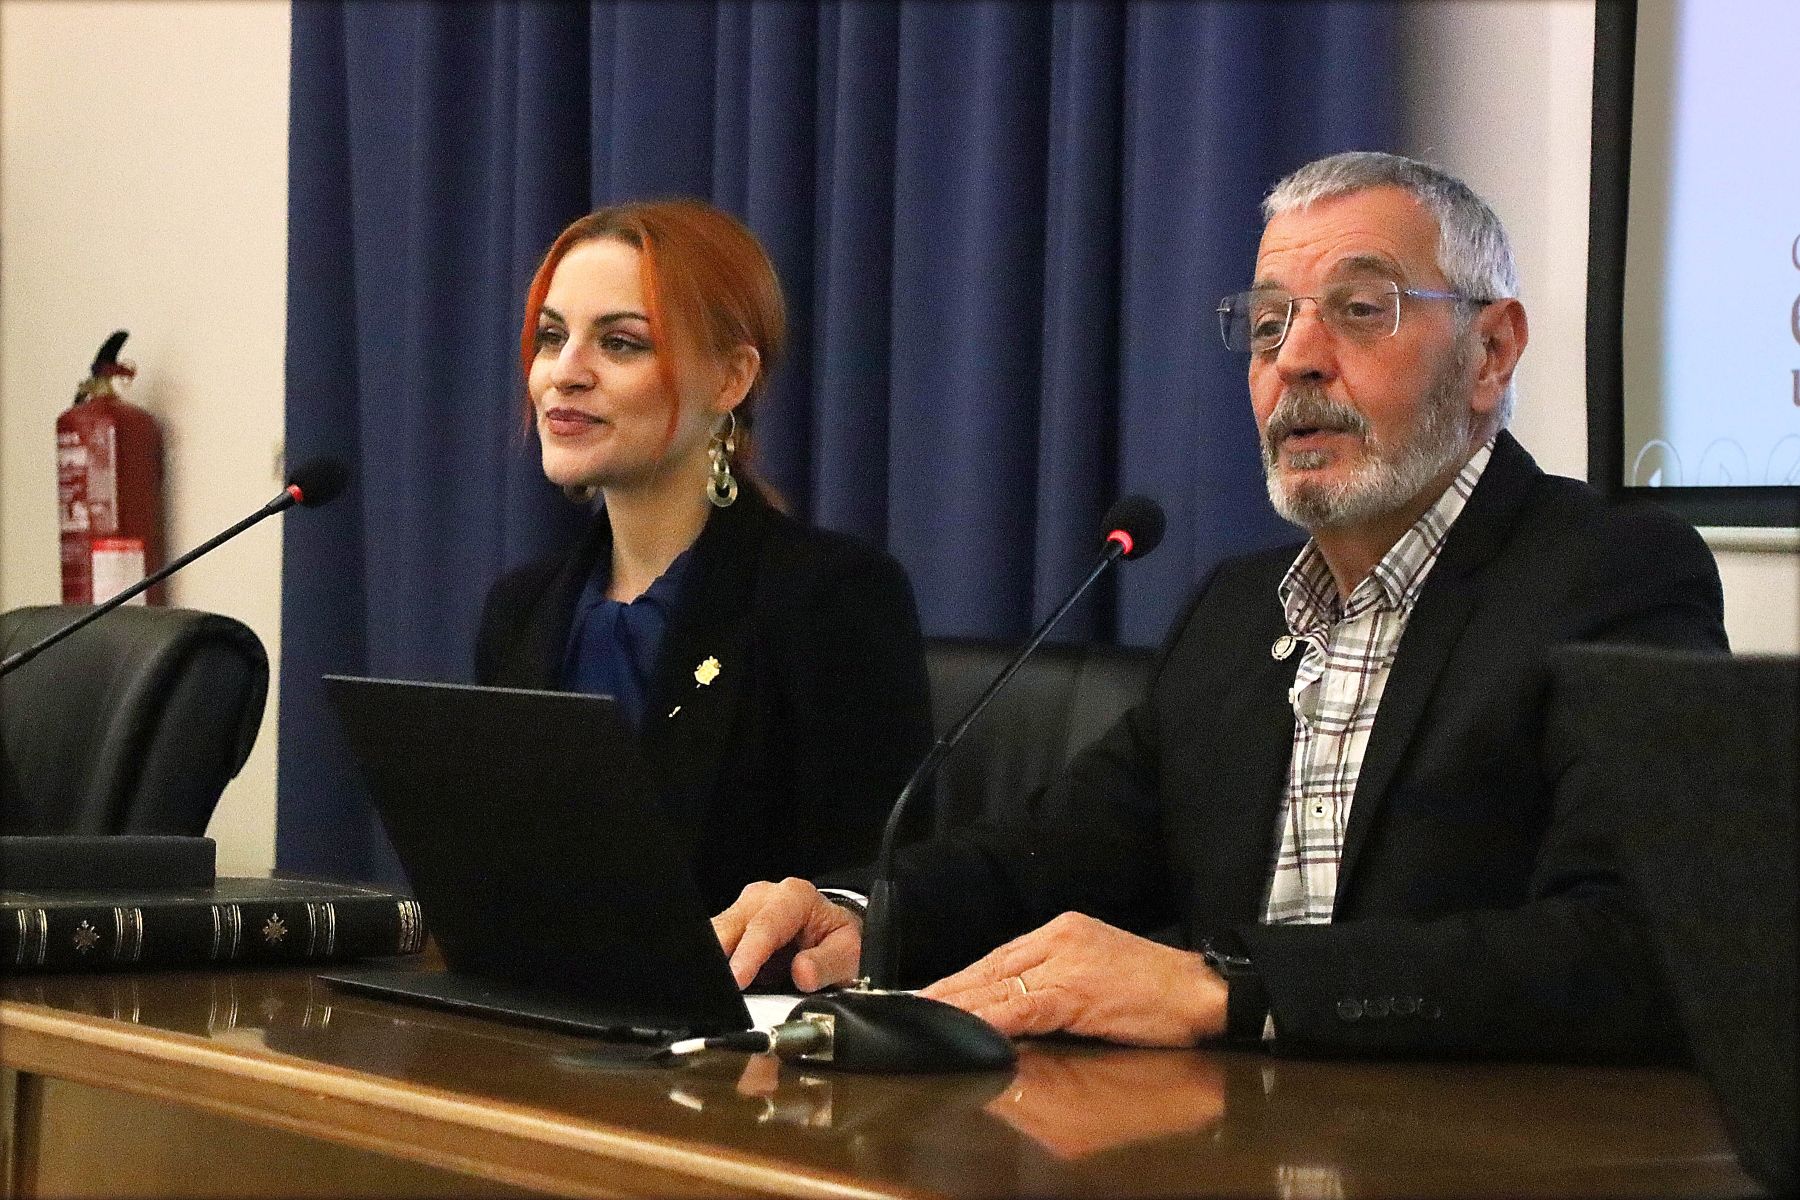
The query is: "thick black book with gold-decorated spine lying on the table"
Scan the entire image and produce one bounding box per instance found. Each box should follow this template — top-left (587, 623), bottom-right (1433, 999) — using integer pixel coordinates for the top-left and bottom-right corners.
top-left (0, 878), bottom-right (425, 972)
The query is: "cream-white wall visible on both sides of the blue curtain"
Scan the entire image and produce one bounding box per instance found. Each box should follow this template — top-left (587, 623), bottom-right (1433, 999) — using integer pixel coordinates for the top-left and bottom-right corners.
top-left (0, 0), bottom-right (1800, 873)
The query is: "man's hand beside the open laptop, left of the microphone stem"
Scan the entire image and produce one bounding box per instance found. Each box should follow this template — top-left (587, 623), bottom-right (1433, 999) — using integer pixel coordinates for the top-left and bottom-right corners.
top-left (713, 878), bottom-right (862, 991)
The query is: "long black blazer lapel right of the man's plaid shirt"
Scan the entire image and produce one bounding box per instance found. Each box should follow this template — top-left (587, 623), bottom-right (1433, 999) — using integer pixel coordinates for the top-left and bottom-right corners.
top-left (1337, 430), bottom-right (1543, 898)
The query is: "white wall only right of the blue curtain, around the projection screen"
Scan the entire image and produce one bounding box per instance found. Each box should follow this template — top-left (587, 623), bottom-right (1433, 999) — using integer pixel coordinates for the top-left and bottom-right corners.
top-left (1404, 0), bottom-right (1800, 653)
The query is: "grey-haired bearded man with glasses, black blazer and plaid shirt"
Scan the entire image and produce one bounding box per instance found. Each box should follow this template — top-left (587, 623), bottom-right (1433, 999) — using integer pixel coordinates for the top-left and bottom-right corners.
top-left (715, 153), bottom-right (1724, 1058)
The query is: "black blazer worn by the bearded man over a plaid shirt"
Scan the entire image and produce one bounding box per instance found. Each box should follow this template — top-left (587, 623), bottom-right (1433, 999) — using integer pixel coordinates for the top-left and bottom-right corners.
top-left (900, 434), bottom-right (1726, 1058)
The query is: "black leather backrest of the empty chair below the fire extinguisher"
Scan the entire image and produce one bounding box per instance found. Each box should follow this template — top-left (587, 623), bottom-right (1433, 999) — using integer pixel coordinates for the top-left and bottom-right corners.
top-left (0, 604), bottom-right (268, 837)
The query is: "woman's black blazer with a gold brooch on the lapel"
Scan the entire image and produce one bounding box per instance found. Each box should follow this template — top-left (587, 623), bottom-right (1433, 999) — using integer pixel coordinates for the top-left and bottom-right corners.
top-left (475, 484), bottom-right (931, 912)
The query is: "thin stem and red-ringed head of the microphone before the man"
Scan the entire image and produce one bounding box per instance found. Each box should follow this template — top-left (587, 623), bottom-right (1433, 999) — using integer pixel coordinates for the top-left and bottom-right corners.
top-left (857, 497), bottom-right (1165, 991)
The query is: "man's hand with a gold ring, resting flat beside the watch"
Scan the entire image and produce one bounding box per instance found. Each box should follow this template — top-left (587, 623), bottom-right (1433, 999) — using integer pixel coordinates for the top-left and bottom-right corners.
top-left (921, 912), bottom-right (1226, 1045)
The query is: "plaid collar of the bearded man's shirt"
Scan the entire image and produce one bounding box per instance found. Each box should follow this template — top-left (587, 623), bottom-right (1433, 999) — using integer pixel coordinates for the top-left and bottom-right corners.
top-left (1278, 437), bottom-right (1494, 637)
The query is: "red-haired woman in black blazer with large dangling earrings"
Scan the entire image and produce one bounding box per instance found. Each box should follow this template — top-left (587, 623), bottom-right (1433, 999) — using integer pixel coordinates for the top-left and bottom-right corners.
top-left (475, 200), bottom-right (931, 912)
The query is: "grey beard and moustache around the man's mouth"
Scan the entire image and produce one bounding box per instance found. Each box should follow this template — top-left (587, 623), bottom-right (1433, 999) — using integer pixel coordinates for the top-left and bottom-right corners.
top-left (1262, 345), bottom-right (1472, 531)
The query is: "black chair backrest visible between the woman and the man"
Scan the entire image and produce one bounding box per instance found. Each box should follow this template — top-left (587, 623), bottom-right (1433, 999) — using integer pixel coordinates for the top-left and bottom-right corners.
top-left (925, 639), bottom-right (1156, 829)
